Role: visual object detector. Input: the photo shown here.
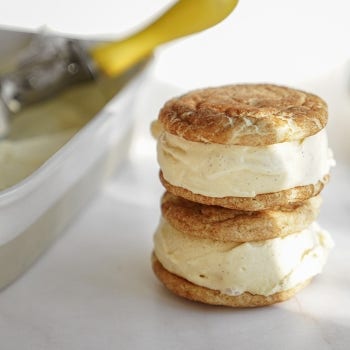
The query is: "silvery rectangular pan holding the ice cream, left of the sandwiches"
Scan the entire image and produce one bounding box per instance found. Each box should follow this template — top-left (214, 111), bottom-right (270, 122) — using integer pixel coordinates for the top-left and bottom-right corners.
top-left (0, 28), bottom-right (146, 288)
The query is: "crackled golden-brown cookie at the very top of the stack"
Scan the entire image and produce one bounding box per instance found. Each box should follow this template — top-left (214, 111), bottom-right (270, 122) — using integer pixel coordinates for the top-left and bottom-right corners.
top-left (158, 84), bottom-right (328, 146)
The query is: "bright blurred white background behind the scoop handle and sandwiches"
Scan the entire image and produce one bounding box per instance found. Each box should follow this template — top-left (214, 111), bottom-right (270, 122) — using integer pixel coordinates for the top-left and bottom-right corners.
top-left (0, 0), bottom-right (350, 159)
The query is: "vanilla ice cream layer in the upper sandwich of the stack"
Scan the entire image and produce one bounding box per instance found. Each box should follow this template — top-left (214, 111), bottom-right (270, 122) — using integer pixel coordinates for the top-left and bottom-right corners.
top-left (158, 129), bottom-right (334, 197)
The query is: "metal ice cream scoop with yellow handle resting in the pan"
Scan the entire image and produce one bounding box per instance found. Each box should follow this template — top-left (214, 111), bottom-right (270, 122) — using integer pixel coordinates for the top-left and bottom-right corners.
top-left (0, 0), bottom-right (238, 137)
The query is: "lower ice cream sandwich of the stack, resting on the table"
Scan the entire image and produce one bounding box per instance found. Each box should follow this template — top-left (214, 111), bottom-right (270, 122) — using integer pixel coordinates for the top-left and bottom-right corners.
top-left (152, 194), bottom-right (333, 307)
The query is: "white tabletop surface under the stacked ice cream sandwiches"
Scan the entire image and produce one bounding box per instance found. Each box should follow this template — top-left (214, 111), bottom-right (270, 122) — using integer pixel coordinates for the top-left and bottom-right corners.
top-left (0, 74), bottom-right (350, 350)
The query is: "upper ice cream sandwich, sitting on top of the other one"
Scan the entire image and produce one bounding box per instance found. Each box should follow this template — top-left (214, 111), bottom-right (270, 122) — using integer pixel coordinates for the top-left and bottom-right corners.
top-left (153, 84), bottom-right (333, 211)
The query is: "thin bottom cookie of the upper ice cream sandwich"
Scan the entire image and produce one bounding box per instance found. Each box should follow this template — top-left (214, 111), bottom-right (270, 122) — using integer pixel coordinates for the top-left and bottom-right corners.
top-left (159, 171), bottom-right (329, 211)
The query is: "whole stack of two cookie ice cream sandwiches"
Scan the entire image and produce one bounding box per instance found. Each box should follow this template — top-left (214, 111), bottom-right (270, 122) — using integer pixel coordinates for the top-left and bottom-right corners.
top-left (152, 84), bottom-right (334, 307)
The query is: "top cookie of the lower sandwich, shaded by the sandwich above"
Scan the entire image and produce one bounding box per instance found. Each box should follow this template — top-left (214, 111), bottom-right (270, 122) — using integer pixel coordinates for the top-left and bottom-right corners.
top-left (161, 192), bottom-right (321, 242)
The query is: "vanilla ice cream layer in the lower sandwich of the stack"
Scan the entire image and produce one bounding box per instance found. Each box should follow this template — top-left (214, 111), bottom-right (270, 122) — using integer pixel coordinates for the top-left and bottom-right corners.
top-left (154, 219), bottom-right (333, 296)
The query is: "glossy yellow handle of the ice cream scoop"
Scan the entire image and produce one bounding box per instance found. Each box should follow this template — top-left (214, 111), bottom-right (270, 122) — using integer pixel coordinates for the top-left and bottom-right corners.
top-left (91, 0), bottom-right (238, 76)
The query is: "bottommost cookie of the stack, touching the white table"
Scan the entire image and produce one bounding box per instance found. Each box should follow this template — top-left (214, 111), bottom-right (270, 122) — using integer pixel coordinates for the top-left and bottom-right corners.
top-left (152, 253), bottom-right (311, 307)
